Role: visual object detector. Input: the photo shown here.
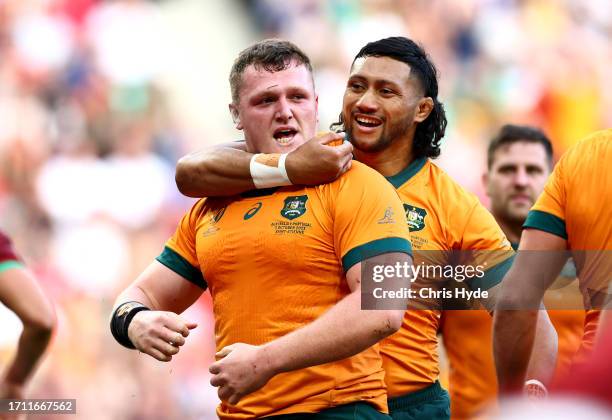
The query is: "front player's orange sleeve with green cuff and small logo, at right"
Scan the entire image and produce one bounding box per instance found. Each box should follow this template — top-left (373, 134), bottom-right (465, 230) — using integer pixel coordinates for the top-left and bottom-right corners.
top-left (330, 164), bottom-right (412, 271)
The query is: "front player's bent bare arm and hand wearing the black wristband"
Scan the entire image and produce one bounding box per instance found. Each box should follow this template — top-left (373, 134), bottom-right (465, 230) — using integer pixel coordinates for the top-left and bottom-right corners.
top-left (115, 261), bottom-right (204, 362)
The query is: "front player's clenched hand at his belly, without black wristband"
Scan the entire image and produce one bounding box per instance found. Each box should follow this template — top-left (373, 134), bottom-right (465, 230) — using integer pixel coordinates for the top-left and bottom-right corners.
top-left (209, 343), bottom-right (275, 405)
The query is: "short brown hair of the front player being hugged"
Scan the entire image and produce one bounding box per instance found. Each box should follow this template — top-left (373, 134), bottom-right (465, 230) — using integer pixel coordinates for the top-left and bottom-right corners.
top-left (229, 38), bottom-right (312, 103)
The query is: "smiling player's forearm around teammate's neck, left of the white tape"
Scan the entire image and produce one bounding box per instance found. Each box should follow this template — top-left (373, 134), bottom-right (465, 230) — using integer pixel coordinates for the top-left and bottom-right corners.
top-left (175, 147), bottom-right (255, 197)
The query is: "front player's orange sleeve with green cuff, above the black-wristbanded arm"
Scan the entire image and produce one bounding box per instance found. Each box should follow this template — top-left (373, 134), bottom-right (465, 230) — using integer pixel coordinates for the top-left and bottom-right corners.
top-left (156, 199), bottom-right (207, 289)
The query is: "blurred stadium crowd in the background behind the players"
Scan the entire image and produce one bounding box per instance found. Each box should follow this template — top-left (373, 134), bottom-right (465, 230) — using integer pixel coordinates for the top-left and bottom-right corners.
top-left (0, 0), bottom-right (612, 419)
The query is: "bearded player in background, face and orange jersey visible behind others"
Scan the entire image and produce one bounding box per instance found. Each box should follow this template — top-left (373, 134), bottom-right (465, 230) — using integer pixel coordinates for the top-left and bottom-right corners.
top-left (441, 124), bottom-right (585, 419)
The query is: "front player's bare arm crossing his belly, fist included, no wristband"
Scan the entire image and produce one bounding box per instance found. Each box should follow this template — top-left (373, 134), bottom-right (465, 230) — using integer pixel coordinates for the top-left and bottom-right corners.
top-left (210, 253), bottom-right (412, 404)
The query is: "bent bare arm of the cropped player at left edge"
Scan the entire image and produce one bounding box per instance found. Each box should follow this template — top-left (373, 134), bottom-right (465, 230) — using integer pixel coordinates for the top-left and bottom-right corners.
top-left (0, 268), bottom-right (55, 398)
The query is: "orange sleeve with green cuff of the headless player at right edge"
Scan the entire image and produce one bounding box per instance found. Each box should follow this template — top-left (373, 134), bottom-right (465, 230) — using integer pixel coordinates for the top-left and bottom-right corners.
top-left (523, 154), bottom-right (569, 239)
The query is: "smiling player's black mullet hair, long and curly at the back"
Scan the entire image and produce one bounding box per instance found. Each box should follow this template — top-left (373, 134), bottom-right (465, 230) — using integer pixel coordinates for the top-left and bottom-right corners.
top-left (330, 36), bottom-right (447, 159)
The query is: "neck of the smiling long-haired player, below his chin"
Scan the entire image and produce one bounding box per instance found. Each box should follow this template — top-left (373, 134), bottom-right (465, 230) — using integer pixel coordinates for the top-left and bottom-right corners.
top-left (353, 139), bottom-right (413, 176)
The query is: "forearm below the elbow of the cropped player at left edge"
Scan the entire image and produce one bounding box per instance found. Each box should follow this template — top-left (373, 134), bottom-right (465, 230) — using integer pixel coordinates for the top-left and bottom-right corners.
top-left (5, 325), bottom-right (52, 385)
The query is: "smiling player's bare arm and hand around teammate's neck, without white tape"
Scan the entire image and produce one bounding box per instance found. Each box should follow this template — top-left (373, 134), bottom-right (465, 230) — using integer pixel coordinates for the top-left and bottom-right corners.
top-left (175, 133), bottom-right (353, 197)
